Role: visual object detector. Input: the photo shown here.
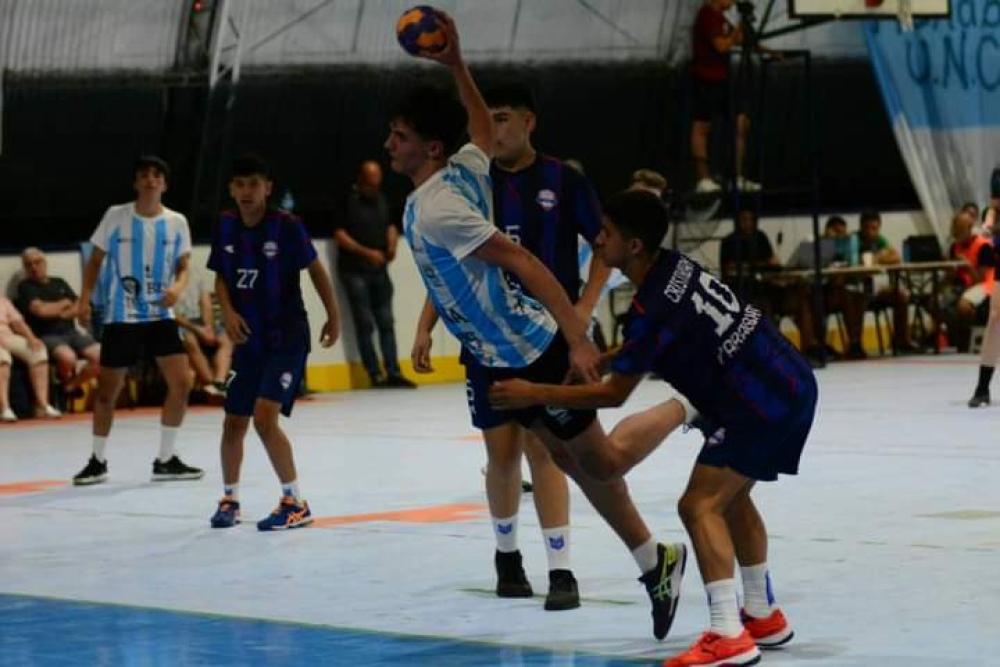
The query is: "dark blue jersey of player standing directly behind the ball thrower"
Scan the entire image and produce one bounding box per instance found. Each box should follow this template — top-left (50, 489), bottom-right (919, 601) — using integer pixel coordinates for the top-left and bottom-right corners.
top-left (490, 153), bottom-right (601, 303)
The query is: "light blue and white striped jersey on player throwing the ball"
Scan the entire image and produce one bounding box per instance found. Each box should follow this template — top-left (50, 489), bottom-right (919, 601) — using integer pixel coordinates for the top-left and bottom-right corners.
top-left (403, 144), bottom-right (557, 368)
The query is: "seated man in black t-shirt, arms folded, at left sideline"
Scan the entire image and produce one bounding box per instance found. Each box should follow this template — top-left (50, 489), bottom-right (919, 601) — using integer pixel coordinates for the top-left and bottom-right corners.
top-left (17, 247), bottom-right (101, 391)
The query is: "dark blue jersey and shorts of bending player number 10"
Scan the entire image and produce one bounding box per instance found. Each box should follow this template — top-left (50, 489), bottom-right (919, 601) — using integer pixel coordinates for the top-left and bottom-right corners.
top-left (612, 250), bottom-right (817, 480)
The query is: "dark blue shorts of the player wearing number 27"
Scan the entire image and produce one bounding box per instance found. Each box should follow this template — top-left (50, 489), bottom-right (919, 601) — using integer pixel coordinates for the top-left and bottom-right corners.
top-left (224, 350), bottom-right (309, 417)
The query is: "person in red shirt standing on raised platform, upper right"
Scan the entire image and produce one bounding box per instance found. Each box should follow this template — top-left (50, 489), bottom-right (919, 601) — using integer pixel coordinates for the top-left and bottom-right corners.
top-left (691, 0), bottom-right (760, 192)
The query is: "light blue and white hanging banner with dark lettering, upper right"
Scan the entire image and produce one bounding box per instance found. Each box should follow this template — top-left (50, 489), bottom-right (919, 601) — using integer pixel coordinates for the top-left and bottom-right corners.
top-left (865, 0), bottom-right (1000, 239)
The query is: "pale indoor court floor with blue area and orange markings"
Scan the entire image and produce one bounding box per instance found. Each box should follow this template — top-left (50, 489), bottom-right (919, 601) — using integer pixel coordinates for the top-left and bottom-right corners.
top-left (0, 355), bottom-right (1000, 667)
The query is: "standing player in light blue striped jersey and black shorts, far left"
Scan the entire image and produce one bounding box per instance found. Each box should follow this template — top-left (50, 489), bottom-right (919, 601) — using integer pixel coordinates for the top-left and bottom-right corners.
top-left (73, 156), bottom-right (205, 486)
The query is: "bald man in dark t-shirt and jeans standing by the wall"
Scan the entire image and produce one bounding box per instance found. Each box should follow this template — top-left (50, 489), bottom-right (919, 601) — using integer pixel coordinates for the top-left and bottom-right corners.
top-left (333, 161), bottom-right (416, 388)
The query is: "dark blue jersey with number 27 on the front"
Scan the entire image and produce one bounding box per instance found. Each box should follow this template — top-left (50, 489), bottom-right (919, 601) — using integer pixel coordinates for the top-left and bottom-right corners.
top-left (208, 210), bottom-right (317, 354)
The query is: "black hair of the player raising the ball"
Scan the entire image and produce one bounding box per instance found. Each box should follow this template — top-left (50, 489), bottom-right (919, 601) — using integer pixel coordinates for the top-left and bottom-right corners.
top-left (390, 86), bottom-right (469, 155)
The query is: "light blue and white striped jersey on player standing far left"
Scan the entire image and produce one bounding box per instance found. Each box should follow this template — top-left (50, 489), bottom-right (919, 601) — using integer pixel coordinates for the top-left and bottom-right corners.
top-left (90, 203), bottom-right (191, 324)
